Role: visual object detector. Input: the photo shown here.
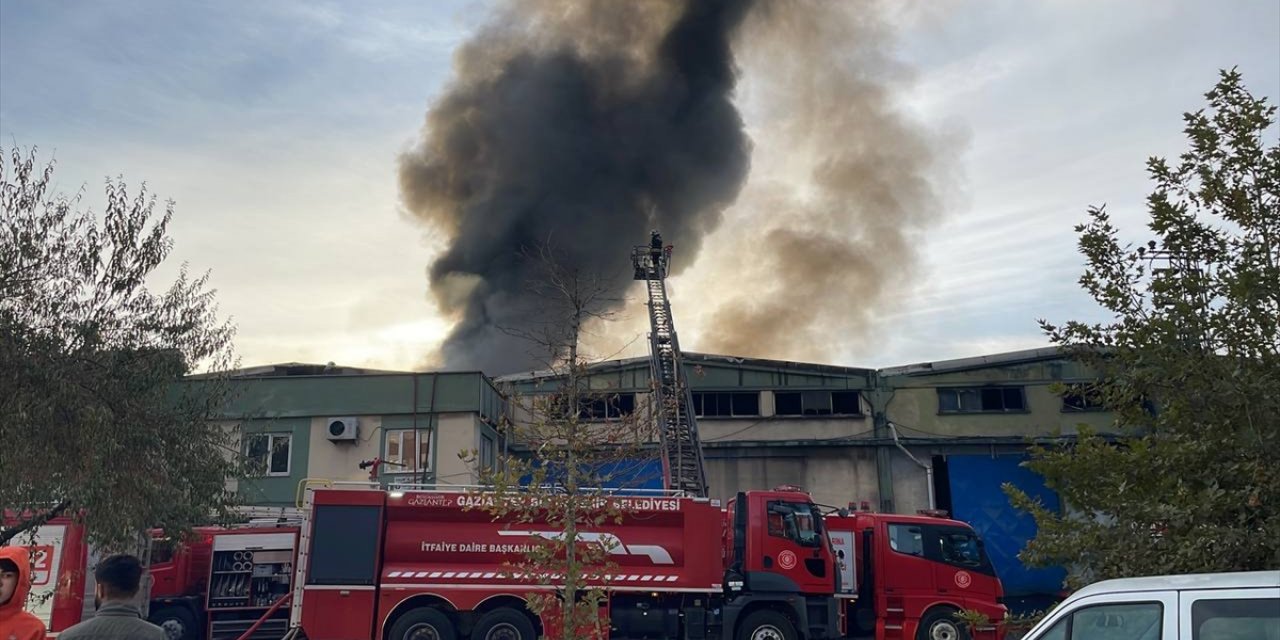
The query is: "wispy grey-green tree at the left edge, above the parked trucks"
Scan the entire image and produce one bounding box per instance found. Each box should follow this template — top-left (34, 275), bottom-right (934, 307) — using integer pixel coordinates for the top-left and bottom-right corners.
top-left (0, 148), bottom-right (239, 548)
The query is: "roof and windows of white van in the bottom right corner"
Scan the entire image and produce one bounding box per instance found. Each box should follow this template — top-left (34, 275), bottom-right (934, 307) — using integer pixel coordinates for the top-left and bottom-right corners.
top-left (1023, 571), bottom-right (1280, 640)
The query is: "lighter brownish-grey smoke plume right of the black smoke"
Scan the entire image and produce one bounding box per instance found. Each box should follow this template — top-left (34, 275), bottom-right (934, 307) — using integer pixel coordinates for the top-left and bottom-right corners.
top-left (691, 0), bottom-right (948, 364)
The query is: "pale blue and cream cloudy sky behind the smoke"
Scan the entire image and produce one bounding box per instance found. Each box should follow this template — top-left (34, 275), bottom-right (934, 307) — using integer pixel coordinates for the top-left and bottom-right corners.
top-left (0, 0), bottom-right (1280, 369)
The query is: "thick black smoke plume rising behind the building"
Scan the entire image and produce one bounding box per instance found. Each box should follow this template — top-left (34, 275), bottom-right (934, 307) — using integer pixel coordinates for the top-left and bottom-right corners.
top-left (399, 0), bottom-right (751, 374)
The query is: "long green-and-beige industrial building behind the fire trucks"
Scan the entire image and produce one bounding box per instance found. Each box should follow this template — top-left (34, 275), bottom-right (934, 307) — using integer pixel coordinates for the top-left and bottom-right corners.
top-left (204, 348), bottom-right (1112, 604)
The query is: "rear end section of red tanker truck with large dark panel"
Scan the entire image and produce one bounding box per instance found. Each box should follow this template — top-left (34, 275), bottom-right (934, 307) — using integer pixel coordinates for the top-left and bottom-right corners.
top-left (298, 492), bottom-right (385, 640)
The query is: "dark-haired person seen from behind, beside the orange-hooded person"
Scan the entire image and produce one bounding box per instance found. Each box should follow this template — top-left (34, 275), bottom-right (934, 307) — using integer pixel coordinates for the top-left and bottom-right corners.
top-left (58, 554), bottom-right (166, 640)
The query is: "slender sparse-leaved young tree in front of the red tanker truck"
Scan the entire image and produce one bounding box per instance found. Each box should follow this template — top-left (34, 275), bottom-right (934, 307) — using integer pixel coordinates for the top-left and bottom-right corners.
top-left (463, 242), bottom-right (657, 639)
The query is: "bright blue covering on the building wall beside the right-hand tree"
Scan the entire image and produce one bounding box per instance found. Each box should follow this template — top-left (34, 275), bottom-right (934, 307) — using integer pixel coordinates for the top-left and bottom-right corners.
top-left (947, 456), bottom-right (1066, 596)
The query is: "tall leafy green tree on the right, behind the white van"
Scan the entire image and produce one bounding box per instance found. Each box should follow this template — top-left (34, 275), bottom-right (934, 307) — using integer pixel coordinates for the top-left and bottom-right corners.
top-left (1006, 69), bottom-right (1280, 584)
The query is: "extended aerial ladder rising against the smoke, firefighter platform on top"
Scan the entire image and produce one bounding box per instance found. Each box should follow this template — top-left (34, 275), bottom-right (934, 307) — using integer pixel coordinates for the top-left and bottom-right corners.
top-left (631, 232), bottom-right (707, 498)
